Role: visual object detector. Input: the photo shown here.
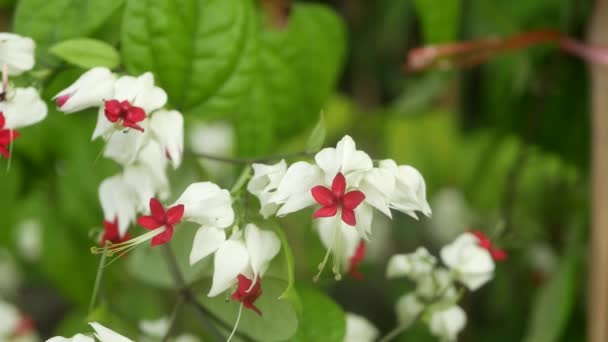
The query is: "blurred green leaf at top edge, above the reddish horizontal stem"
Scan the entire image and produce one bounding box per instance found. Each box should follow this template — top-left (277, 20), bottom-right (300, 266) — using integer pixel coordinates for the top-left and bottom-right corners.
top-left (414, 0), bottom-right (461, 44)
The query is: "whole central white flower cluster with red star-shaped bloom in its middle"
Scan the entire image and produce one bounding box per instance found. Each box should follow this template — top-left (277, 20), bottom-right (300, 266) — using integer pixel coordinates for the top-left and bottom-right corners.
top-left (247, 136), bottom-right (431, 279)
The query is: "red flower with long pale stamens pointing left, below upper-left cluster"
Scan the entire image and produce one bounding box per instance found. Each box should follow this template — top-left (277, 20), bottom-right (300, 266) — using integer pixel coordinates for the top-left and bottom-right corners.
top-left (137, 198), bottom-right (184, 246)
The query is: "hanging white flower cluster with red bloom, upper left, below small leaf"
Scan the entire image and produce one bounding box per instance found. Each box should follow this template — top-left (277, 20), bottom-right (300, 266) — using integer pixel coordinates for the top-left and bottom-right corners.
top-left (54, 67), bottom-right (184, 244)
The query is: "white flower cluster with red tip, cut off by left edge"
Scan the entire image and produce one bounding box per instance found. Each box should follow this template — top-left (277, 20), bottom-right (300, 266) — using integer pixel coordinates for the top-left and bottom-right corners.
top-left (0, 33), bottom-right (47, 159)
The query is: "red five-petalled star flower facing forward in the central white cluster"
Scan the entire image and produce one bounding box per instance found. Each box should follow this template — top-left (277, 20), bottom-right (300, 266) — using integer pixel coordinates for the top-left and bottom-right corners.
top-left (311, 172), bottom-right (365, 226)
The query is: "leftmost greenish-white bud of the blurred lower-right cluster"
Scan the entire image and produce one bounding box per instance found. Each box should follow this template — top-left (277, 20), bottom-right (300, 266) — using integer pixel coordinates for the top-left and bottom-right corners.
top-left (386, 247), bottom-right (437, 280)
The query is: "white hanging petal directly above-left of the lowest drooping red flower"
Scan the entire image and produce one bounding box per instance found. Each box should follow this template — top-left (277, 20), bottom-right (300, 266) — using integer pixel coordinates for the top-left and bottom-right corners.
top-left (209, 240), bottom-right (249, 297)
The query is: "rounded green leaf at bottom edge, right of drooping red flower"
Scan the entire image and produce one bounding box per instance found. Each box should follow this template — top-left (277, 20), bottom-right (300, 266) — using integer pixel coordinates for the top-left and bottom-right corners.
top-left (290, 287), bottom-right (346, 342)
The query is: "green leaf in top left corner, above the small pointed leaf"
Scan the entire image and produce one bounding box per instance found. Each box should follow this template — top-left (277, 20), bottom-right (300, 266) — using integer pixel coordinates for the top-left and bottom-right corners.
top-left (14, 0), bottom-right (124, 62)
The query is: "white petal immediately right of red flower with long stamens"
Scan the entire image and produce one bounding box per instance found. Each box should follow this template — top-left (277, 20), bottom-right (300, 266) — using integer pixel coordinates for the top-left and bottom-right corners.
top-left (174, 182), bottom-right (234, 228)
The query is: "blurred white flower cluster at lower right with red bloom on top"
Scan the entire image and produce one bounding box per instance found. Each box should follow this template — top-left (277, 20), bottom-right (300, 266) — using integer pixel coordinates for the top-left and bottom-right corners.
top-left (386, 231), bottom-right (507, 341)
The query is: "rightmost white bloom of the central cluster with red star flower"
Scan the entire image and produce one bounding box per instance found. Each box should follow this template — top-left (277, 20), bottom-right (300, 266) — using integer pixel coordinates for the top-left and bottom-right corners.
top-left (379, 159), bottom-right (431, 218)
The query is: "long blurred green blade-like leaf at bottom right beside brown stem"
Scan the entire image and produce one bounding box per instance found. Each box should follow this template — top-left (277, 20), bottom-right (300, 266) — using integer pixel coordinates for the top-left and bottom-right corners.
top-left (524, 227), bottom-right (583, 342)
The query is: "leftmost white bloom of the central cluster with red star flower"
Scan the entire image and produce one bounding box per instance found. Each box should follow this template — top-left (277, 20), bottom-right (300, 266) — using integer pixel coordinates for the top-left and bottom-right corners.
top-left (247, 160), bottom-right (287, 218)
